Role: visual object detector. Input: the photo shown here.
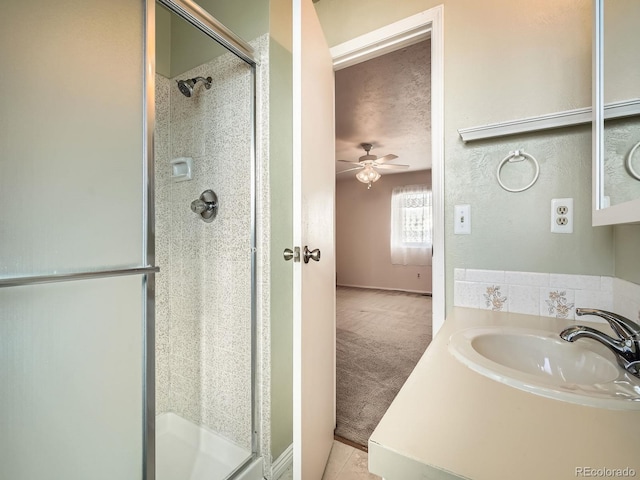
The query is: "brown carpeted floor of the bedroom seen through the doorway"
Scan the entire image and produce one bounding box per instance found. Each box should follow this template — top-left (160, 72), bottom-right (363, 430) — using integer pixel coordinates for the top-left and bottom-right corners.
top-left (335, 287), bottom-right (431, 446)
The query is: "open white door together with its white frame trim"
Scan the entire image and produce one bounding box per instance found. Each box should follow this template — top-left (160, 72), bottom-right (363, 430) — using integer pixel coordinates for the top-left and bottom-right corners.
top-left (292, 1), bottom-right (444, 478)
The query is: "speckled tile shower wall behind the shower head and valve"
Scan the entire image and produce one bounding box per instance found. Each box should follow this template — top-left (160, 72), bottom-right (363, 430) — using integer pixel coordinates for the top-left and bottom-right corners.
top-left (155, 39), bottom-right (262, 449)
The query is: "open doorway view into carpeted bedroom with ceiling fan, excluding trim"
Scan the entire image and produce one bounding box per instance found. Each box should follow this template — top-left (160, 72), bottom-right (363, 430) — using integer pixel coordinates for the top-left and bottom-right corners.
top-left (335, 39), bottom-right (432, 449)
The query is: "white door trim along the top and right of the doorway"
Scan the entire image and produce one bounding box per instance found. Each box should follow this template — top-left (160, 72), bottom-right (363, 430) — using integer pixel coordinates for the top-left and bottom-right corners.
top-left (331, 5), bottom-right (446, 335)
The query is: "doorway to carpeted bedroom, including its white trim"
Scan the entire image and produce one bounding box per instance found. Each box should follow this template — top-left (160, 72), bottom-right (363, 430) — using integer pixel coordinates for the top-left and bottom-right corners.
top-left (332, 9), bottom-right (444, 449)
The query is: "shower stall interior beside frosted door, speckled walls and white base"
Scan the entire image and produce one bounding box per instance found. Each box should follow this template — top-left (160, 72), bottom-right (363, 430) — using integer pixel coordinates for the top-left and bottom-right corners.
top-left (154, 0), bottom-right (262, 480)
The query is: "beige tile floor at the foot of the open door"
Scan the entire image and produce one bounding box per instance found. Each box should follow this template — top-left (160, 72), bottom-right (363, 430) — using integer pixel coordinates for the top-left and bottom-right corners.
top-left (280, 440), bottom-right (381, 480)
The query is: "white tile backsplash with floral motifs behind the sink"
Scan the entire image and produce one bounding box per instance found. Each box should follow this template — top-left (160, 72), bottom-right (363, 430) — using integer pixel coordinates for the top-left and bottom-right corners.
top-left (454, 268), bottom-right (640, 321)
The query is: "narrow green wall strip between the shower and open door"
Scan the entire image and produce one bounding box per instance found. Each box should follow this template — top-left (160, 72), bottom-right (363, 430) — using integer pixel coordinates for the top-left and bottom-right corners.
top-left (269, 0), bottom-right (293, 460)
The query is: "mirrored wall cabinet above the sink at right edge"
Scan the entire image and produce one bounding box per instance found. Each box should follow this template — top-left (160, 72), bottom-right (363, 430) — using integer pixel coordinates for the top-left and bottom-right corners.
top-left (593, 0), bottom-right (640, 226)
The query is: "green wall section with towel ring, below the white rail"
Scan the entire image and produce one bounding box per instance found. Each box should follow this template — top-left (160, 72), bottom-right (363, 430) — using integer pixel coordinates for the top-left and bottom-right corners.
top-left (445, 126), bottom-right (614, 306)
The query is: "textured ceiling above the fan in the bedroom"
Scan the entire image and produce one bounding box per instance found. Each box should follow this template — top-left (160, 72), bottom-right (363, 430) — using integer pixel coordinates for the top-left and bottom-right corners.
top-left (335, 40), bottom-right (431, 178)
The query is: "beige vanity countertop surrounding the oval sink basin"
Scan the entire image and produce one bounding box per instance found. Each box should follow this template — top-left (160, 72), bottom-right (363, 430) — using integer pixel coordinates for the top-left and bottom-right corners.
top-left (369, 308), bottom-right (640, 480)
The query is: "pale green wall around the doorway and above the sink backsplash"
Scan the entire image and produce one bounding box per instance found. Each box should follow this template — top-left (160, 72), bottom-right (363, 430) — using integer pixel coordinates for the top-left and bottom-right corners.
top-left (315, 0), bottom-right (628, 310)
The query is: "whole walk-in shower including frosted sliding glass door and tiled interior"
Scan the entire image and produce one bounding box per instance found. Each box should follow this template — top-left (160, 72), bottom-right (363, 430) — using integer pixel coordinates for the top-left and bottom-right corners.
top-left (0, 0), bottom-right (268, 480)
